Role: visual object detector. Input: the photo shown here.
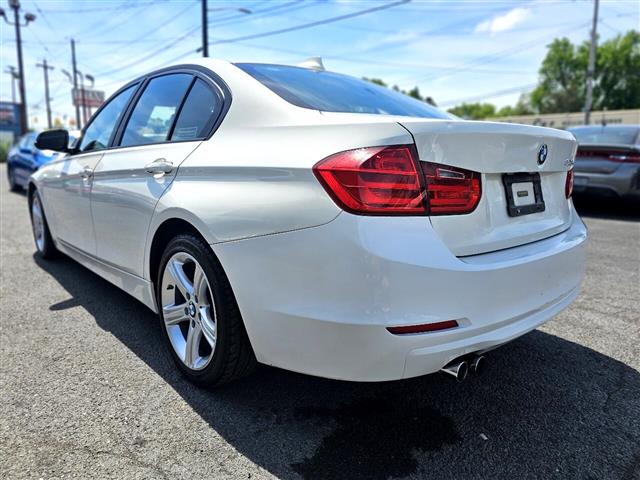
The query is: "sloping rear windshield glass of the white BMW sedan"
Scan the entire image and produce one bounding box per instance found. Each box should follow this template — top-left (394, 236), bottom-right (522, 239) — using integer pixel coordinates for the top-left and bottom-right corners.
top-left (236, 63), bottom-right (455, 119)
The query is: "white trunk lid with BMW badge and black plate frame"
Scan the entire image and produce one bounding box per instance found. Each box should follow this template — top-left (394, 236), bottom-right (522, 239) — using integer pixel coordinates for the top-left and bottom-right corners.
top-left (400, 119), bottom-right (576, 256)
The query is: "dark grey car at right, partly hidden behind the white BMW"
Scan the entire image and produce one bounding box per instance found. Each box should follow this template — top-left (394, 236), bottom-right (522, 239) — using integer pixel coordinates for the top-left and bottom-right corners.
top-left (568, 125), bottom-right (640, 201)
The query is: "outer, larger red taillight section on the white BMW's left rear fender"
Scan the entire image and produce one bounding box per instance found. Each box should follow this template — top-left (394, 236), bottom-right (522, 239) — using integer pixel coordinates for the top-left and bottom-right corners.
top-left (313, 145), bottom-right (426, 215)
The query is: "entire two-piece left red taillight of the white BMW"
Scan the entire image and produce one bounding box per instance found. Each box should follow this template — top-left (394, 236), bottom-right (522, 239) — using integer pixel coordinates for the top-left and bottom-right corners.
top-left (313, 145), bottom-right (482, 215)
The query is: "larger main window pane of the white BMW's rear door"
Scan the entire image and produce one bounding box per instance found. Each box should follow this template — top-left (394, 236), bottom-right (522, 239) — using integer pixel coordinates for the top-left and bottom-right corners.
top-left (120, 73), bottom-right (193, 147)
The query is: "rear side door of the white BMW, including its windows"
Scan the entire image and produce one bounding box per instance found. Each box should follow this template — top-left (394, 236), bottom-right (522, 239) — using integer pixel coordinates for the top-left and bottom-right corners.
top-left (91, 71), bottom-right (222, 276)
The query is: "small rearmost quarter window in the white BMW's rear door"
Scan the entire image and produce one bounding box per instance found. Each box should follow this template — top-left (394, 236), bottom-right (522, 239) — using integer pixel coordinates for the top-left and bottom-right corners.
top-left (171, 79), bottom-right (222, 140)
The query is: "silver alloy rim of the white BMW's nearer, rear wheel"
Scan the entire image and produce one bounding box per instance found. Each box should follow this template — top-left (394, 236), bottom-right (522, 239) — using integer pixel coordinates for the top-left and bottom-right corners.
top-left (161, 252), bottom-right (218, 370)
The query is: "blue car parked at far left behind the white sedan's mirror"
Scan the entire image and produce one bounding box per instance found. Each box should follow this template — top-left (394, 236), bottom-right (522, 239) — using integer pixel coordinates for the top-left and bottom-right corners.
top-left (7, 132), bottom-right (71, 192)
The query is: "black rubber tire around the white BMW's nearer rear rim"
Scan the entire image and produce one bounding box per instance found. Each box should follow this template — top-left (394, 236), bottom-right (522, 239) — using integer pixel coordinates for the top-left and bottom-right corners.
top-left (156, 234), bottom-right (257, 388)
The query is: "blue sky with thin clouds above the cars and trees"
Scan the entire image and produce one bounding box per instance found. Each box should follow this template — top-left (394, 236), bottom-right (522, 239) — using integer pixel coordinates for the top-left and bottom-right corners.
top-left (0, 0), bottom-right (640, 128)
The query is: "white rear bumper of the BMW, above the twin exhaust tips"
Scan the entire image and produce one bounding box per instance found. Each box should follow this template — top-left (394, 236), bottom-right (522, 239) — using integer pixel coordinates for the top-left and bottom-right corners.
top-left (212, 211), bottom-right (586, 381)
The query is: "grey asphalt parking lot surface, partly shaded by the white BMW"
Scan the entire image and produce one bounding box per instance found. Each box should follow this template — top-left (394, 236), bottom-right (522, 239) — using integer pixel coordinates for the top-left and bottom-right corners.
top-left (0, 165), bottom-right (640, 480)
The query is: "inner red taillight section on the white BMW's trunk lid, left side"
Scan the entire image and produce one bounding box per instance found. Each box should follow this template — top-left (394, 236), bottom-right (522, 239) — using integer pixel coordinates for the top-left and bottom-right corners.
top-left (420, 162), bottom-right (482, 215)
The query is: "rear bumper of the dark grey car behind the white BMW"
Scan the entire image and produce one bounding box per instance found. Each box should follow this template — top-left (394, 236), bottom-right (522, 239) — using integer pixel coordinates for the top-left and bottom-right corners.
top-left (573, 164), bottom-right (640, 198)
